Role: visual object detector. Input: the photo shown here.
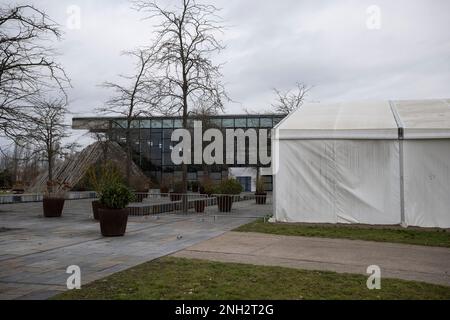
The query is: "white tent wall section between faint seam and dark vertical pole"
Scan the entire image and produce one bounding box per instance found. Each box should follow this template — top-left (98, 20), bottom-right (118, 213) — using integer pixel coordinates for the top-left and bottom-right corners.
top-left (336, 140), bottom-right (401, 225)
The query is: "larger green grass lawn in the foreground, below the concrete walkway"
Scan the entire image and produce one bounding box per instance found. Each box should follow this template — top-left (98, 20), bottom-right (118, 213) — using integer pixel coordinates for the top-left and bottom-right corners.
top-left (54, 257), bottom-right (450, 300)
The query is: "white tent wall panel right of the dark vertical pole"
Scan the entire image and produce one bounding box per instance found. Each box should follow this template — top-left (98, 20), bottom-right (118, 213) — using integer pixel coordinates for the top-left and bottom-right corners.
top-left (404, 139), bottom-right (450, 228)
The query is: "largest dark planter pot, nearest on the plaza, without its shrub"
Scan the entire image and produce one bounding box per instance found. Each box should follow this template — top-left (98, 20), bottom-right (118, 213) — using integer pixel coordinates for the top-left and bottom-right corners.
top-left (98, 208), bottom-right (128, 237)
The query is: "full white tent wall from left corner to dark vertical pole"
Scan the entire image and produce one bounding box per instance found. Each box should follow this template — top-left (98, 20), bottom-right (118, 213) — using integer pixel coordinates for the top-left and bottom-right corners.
top-left (275, 140), bottom-right (400, 224)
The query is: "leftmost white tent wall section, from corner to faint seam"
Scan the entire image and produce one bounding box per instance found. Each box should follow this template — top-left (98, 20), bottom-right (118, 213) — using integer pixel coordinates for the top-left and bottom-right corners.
top-left (274, 140), bottom-right (337, 223)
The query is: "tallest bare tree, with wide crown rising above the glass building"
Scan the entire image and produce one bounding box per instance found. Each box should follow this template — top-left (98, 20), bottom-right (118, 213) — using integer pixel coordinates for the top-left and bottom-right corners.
top-left (134, 0), bottom-right (227, 199)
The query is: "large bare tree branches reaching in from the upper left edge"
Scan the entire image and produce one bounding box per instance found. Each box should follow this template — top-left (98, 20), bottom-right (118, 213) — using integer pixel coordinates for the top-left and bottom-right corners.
top-left (0, 5), bottom-right (70, 139)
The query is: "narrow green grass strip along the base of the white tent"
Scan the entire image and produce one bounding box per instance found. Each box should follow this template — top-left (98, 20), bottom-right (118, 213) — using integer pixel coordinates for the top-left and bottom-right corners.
top-left (235, 219), bottom-right (450, 248)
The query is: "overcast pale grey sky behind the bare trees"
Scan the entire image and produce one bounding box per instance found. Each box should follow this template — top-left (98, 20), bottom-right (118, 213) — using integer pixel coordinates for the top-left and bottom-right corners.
top-left (0, 0), bottom-right (450, 144)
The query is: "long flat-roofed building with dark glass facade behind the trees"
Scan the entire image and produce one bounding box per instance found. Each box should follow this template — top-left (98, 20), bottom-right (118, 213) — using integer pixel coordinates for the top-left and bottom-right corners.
top-left (73, 114), bottom-right (285, 190)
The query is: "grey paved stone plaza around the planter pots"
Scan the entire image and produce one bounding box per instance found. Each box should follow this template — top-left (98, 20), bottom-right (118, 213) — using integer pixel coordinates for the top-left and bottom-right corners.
top-left (0, 200), bottom-right (272, 299)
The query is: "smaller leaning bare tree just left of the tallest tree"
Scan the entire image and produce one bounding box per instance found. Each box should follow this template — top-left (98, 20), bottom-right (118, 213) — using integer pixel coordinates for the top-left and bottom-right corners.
top-left (98, 49), bottom-right (161, 185)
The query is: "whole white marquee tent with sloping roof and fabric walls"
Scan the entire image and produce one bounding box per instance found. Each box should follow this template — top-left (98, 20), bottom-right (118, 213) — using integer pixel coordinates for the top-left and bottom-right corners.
top-left (272, 100), bottom-right (450, 228)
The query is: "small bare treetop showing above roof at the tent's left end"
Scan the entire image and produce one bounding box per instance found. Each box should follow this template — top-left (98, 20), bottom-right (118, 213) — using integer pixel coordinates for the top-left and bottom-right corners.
top-left (272, 83), bottom-right (312, 114)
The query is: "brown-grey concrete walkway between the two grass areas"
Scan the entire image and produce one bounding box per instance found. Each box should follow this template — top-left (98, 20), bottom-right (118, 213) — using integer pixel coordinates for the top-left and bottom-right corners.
top-left (174, 232), bottom-right (450, 286)
